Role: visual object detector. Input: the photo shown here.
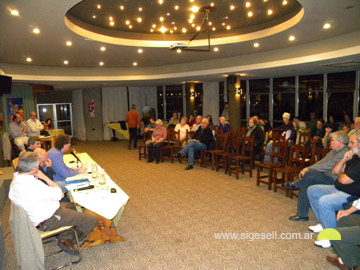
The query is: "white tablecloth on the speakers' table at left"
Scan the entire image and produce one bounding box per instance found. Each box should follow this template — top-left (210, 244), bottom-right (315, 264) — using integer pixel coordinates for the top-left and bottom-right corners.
top-left (64, 153), bottom-right (129, 219)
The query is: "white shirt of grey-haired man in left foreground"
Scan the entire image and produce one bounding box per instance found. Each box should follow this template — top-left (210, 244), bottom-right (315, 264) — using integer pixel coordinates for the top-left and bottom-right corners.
top-left (9, 173), bottom-right (62, 226)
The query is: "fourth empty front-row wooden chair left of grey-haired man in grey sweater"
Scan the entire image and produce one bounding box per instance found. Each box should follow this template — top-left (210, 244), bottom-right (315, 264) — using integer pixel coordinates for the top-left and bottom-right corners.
top-left (215, 130), bottom-right (242, 174)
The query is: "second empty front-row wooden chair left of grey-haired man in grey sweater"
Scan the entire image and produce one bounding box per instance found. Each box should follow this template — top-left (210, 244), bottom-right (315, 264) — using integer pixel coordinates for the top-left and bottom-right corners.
top-left (256, 134), bottom-right (288, 190)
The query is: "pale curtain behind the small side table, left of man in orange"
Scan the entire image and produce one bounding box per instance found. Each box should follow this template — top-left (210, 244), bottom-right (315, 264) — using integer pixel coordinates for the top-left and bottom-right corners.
top-left (102, 86), bottom-right (129, 140)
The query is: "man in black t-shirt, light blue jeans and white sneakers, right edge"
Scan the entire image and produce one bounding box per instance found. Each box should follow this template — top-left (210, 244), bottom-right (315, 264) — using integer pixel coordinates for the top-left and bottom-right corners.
top-left (307, 133), bottom-right (360, 248)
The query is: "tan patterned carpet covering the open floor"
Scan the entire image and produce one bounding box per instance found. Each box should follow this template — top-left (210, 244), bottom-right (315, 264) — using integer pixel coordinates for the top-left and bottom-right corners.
top-left (1, 142), bottom-right (335, 270)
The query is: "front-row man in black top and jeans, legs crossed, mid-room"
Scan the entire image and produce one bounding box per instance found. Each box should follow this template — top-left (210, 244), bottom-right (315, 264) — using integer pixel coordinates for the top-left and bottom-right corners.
top-left (179, 118), bottom-right (214, 170)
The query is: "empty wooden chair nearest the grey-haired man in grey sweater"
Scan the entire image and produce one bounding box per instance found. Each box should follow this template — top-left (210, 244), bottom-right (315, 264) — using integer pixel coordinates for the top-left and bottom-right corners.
top-left (273, 144), bottom-right (310, 196)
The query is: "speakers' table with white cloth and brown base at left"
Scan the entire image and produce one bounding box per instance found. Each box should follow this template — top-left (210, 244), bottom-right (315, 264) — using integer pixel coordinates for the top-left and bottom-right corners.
top-left (64, 153), bottom-right (129, 248)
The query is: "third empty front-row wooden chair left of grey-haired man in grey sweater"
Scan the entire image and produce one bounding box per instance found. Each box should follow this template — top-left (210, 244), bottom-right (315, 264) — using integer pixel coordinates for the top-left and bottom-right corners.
top-left (229, 137), bottom-right (254, 179)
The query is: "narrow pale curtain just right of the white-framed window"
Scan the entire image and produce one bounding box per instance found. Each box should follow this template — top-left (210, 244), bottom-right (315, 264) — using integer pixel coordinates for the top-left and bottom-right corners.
top-left (72, 89), bottom-right (86, 141)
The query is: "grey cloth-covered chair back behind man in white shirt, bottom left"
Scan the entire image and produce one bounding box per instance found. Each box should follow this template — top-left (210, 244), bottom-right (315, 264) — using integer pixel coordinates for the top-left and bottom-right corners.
top-left (10, 203), bottom-right (45, 270)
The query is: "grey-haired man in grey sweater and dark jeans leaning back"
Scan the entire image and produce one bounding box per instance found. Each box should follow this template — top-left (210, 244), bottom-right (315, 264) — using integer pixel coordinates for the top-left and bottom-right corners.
top-left (285, 131), bottom-right (349, 221)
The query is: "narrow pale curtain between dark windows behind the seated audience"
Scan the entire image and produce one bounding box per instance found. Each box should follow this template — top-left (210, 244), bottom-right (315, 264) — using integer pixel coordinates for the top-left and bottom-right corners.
top-left (203, 82), bottom-right (219, 125)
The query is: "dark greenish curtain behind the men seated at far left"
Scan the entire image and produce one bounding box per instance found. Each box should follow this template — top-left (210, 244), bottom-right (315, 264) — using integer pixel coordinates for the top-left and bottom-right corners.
top-left (2, 86), bottom-right (36, 131)
